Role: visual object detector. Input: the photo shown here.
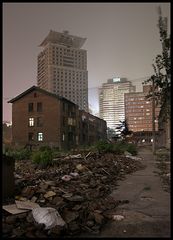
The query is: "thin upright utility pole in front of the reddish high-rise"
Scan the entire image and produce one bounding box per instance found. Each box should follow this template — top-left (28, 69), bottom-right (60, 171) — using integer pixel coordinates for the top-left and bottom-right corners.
top-left (152, 77), bottom-right (156, 154)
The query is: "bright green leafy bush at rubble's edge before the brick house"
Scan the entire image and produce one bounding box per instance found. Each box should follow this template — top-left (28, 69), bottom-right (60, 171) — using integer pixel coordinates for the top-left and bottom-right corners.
top-left (32, 150), bottom-right (53, 168)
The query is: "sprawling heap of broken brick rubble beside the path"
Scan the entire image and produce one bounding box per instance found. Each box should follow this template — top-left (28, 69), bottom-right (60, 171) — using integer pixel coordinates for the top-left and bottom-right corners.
top-left (3, 153), bottom-right (145, 238)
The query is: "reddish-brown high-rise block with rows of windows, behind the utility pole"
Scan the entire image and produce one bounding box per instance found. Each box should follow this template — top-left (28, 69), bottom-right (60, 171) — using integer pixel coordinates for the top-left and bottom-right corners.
top-left (125, 85), bottom-right (160, 132)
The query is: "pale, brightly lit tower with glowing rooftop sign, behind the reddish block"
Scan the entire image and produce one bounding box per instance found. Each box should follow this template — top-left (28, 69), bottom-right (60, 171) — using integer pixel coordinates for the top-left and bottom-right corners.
top-left (99, 78), bottom-right (135, 130)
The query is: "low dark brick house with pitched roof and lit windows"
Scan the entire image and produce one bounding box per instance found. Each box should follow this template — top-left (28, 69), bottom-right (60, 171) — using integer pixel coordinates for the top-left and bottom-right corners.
top-left (9, 86), bottom-right (106, 149)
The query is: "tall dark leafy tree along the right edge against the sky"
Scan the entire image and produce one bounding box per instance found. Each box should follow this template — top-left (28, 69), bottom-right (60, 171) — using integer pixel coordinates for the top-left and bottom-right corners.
top-left (143, 6), bottom-right (171, 120)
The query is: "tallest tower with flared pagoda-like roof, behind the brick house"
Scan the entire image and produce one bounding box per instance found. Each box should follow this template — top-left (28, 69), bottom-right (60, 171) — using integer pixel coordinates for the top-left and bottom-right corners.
top-left (37, 30), bottom-right (88, 111)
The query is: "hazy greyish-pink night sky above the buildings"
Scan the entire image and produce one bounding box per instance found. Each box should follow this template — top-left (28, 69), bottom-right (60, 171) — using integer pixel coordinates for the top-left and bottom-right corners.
top-left (3, 3), bottom-right (170, 121)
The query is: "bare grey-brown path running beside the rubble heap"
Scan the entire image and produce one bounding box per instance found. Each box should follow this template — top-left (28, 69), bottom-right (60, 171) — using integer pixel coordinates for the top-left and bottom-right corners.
top-left (81, 149), bottom-right (170, 238)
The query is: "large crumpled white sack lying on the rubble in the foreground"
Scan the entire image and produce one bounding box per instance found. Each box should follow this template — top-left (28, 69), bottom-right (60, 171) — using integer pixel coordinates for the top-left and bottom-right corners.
top-left (32, 207), bottom-right (66, 229)
